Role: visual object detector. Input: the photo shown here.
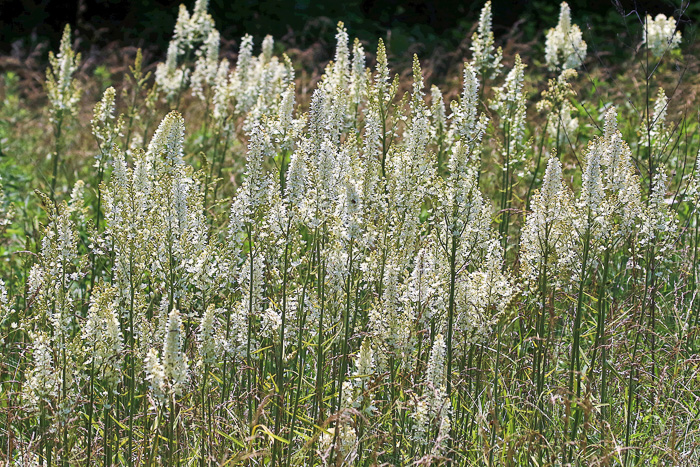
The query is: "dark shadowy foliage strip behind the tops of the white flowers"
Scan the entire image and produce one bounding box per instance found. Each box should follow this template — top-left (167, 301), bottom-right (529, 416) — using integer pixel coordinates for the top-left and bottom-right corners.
top-left (0, 0), bottom-right (700, 59)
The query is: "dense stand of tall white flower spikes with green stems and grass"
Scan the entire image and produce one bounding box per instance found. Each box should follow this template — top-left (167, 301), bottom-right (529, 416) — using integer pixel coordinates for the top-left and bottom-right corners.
top-left (0, 0), bottom-right (700, 465)
